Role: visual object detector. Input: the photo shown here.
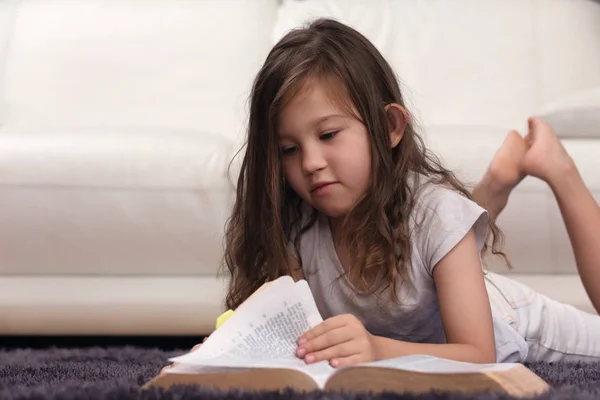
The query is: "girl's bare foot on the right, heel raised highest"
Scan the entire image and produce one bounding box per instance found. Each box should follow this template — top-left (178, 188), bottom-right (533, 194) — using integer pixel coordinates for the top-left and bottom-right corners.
top-left (523, 118), bottom-right (575, 186)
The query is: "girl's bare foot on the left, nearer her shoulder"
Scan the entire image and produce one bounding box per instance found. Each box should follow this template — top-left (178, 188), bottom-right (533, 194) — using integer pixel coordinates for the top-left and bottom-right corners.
top-left (486, 131), bottom-right (529, 193)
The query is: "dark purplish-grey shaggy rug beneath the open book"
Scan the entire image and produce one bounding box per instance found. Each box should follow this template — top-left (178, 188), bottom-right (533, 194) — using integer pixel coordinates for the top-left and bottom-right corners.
top-left (0, 347), bottom-right (600, 400)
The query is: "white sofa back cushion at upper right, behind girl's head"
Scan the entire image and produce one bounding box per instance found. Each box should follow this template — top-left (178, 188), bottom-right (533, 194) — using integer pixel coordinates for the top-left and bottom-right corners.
top-left (275, 0), bottom-right (600, 132)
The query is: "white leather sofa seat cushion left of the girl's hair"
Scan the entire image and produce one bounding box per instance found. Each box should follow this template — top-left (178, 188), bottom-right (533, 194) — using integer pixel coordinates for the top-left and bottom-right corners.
top-left (0, 129), bottom-right (233, 277)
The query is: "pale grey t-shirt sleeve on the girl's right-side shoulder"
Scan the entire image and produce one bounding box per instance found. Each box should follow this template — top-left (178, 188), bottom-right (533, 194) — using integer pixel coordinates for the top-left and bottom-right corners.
top-left (413, 185), bottom-right (488, 275)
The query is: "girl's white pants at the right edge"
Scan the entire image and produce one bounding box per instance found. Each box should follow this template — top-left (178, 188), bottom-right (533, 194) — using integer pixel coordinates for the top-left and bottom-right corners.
top-left (485, 272), bottom-right (600, 362)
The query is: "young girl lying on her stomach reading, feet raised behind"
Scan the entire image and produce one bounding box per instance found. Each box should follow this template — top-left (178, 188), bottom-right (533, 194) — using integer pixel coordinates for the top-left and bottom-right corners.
top-left (218, 19), bottom-right (600, 366)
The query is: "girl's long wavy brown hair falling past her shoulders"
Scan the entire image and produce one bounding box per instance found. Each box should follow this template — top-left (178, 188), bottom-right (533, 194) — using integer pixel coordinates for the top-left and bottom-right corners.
top-left (224, 19), bottom-right (502, 309)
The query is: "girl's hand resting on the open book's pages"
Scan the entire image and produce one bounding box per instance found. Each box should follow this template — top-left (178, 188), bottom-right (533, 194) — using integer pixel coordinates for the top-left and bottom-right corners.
top-left (296, 314), bottom-right (377, 367)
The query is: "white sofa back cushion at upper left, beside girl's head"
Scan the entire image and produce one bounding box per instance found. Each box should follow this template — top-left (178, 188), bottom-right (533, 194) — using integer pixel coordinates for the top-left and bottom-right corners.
top-left (5, 0), bottom-right (277, 147)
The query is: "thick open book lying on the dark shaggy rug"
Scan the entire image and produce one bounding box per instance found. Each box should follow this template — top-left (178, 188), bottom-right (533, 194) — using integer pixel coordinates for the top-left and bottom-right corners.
top-left (144, 276), bottom-right (549, 396)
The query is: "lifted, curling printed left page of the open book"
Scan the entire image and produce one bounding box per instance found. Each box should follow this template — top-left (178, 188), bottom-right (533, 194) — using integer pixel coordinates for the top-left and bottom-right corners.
top-left (170, 277), bottom-right (323, 367)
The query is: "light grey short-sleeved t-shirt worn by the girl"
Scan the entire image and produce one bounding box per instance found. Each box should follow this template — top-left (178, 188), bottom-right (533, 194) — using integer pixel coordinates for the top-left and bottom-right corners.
top-left (292, 184), bottom-right (527, 362)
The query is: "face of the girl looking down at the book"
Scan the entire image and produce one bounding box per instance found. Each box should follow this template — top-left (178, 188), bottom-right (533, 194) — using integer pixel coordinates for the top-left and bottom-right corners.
top-left (278, 80), bottom-right (371, 219)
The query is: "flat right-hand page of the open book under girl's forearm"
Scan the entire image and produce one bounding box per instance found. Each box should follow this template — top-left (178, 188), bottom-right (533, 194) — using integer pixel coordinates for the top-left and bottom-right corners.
top-left (352, 355), bottom-right (516, 374)
